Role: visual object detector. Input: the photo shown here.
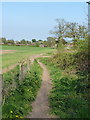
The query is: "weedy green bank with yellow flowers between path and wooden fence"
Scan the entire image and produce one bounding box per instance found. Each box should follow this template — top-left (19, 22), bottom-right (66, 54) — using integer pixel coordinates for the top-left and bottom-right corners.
top-left (2, 61), bottom-right (42, 118)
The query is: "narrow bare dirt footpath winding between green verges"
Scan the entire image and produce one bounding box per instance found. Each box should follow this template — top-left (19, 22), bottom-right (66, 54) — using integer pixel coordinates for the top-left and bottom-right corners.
top-left (27, 61), bottom-right (53, 118)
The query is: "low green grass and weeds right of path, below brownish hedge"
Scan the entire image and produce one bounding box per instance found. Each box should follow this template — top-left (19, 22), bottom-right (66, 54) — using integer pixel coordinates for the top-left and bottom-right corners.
top-left (40, 58), bottom-right (89, 118)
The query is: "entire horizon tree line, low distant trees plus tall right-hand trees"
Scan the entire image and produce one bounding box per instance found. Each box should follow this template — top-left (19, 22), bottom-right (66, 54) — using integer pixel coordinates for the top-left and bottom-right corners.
top-left (0, 19), bottom-right (88, 48)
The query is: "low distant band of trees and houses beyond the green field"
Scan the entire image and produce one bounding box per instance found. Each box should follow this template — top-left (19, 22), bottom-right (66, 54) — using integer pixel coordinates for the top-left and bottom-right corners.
top-left (0, 37), bottom-right (59, 48)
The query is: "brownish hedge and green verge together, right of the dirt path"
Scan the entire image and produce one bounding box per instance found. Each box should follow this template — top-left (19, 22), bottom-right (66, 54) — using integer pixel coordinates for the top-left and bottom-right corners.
top-left (41, 40), bottom-right (90, 118)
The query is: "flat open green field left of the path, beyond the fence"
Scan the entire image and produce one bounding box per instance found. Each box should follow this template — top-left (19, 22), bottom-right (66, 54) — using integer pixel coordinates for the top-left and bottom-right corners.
top-left (0, 46), bottom-right (55, 68)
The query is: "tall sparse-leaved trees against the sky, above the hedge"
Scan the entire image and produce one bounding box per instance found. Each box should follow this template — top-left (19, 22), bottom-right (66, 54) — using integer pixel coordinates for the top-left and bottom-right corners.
top-left (51, 19), bottom-right (88, 44)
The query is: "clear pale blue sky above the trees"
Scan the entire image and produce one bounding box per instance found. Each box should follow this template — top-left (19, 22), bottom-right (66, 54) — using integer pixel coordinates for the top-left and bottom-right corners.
top-left (0, 2), bottom-right (87, 40)
